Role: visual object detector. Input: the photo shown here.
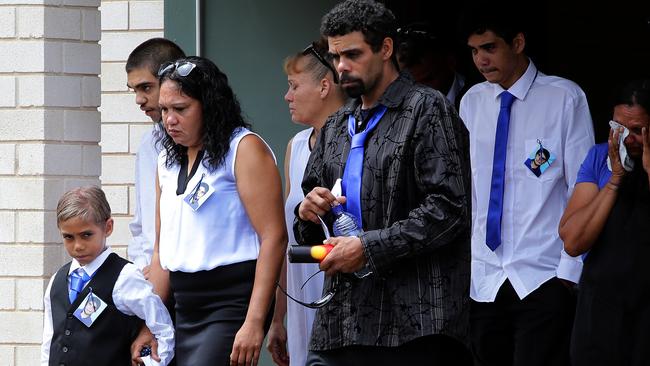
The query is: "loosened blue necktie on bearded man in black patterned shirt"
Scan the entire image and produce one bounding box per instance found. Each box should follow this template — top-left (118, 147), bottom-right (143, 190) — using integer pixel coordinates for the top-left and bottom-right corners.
top-left (342, 105), bottom-right (386, 228)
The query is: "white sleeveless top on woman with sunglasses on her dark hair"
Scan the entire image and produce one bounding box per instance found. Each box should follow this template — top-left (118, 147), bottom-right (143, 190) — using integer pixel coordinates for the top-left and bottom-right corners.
top-left (158, 128), bottom-right (271, 272)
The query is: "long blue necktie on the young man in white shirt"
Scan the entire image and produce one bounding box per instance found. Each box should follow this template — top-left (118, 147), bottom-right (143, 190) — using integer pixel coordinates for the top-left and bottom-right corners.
top-left (485, 91), bottom-right (515, 251)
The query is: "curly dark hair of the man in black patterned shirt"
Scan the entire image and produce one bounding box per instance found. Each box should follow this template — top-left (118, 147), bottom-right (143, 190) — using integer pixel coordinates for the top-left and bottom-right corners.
top-left (320, 0), bottom-right (397, 52)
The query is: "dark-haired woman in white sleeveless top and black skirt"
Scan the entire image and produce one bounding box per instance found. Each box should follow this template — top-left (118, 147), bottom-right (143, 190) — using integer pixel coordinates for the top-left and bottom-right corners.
top-left (151, 57), bottom-right (287, 366)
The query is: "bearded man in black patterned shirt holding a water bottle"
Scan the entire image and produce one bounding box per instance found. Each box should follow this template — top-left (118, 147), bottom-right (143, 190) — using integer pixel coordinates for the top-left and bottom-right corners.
top-left (294, 0), bottom-right (471, 366)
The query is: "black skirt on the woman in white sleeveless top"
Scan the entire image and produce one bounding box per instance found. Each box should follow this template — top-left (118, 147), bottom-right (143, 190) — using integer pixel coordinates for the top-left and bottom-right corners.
top-left (169, 260), bottom-right (273, 366)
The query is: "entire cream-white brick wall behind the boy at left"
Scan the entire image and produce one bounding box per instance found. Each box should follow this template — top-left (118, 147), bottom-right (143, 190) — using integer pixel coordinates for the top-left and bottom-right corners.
top-left (0, 0), bottom-right (163, 366)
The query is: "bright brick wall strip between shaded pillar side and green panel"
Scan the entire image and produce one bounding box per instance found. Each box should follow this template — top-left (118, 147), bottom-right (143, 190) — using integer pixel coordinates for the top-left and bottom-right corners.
top-left (100, 0), bottom-right (164, 256)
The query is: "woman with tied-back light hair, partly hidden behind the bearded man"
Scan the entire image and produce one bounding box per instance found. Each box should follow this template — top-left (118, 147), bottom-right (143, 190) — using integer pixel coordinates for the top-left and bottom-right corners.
top-left (267, 41), bottom-right (345, 366)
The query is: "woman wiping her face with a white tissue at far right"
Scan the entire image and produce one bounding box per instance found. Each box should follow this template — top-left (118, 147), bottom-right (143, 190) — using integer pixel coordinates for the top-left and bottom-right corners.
top-left (560, 80), bottom-right (650, 366)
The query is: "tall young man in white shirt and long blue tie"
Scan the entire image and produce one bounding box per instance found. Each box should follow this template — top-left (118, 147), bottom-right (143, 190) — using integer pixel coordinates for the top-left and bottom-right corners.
top-left (460, 10), bottom-right (594, 366)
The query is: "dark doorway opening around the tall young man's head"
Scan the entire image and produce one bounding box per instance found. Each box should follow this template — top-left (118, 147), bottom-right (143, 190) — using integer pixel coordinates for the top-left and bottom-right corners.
top-left (384, 0), bottom-right (650, 142)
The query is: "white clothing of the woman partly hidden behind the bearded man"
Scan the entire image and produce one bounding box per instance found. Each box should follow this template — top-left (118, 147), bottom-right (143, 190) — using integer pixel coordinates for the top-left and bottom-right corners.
top-left (284, 128), bottom-right (323, 365)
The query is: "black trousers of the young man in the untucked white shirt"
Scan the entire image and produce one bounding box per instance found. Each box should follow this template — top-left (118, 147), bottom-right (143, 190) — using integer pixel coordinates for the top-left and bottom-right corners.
top-left (470, 278), bottom-right (576, 366)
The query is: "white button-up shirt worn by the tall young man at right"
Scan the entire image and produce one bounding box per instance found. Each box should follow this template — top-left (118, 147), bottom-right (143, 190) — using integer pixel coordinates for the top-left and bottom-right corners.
top-left (460, 61), bottom-right (594, 302)
